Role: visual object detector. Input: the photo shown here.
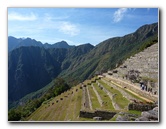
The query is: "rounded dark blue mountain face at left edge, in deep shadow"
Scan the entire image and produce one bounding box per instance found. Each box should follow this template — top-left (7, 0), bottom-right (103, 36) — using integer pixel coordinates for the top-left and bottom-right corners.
top-left (8, 47), bottom-right (60, 100)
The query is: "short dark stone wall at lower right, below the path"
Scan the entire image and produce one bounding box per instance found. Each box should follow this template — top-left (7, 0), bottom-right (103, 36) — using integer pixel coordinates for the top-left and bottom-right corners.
top-left (128, 103), bottom-right (156, 111)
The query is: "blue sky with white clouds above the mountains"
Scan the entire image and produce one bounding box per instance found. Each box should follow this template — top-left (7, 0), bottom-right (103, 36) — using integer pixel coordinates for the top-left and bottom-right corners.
top-left (8, 8), bottom-right (158, 45)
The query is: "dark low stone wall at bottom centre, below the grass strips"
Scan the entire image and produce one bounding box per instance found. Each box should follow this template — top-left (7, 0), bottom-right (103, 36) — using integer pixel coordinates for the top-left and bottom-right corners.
top-left (79, 110), bottom-right (117, 120)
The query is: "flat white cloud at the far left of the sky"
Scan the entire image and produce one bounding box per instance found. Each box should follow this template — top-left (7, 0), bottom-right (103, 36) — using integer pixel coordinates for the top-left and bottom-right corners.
top-left (8, 12), bottom-right (37, 21)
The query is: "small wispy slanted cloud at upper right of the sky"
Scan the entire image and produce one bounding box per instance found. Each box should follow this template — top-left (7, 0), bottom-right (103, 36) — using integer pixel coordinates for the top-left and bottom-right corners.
top-left (113, 8), bottom-right (128, 23)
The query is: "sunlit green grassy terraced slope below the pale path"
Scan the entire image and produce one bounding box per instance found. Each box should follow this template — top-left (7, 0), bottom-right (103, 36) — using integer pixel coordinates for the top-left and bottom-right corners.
top-left (25, 75), bottom-right (157, 121)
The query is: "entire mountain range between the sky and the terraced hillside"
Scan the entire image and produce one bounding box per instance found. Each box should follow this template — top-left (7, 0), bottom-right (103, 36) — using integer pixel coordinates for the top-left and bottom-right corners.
top-left (8, 23), bottom-right (158, 107)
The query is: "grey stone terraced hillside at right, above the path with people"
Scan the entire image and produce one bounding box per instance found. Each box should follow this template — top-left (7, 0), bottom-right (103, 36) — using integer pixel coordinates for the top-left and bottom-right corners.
top-left (108, 43), bottom-right (159, 94)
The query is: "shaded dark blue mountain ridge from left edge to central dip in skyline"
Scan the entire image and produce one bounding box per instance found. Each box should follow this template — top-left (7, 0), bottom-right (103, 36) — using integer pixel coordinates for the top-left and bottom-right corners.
top-left (8, 44), bottom-right (93, 102)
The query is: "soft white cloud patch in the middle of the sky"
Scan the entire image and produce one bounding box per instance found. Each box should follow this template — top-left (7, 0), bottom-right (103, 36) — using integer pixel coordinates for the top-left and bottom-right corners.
top-left (59, 22), bottom-right (80, 36)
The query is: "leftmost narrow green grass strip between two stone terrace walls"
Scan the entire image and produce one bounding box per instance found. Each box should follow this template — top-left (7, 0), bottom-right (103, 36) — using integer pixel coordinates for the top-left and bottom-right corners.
top-left (88, 86), bottom-right (101, 109)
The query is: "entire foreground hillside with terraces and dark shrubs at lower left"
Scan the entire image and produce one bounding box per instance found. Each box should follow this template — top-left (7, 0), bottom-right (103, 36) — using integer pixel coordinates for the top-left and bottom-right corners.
top-left (8, 43), bottom-right (159, 121)
